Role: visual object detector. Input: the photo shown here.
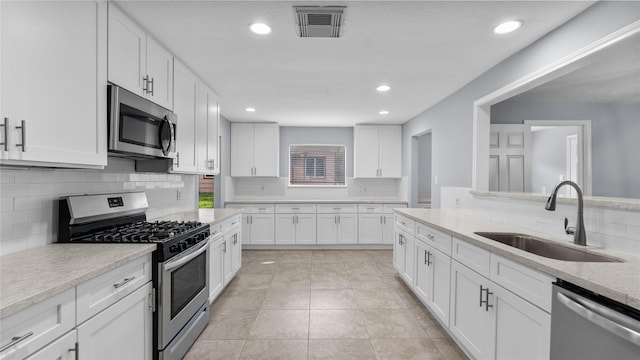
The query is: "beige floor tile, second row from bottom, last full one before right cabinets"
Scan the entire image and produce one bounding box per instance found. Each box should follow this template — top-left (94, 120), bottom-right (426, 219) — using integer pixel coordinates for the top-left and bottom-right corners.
top-left (361, 309), bottom-right (427, 339)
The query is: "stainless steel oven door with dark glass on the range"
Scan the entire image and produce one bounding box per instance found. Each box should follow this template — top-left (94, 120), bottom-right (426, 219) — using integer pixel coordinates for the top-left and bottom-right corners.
top-left (157, 241), bottom-right (209, 350)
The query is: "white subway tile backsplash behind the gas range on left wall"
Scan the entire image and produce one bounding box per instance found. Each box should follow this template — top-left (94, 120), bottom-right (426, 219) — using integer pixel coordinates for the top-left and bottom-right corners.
top-left (0, 157), bottom-right (197, 255)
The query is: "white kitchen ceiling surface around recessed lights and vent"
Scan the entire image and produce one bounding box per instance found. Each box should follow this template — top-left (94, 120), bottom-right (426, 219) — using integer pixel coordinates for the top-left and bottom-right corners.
top-left (118, 0), bottom-right (593, 126)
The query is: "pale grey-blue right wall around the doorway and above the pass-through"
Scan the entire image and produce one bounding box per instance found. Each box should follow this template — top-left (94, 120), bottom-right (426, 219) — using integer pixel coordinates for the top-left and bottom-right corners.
top-left (403, 1), bottom-right (640, 207)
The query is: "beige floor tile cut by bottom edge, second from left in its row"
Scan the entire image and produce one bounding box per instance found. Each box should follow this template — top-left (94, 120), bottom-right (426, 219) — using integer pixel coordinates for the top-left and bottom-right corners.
top-left (240, 340), bottom-right (309, 360)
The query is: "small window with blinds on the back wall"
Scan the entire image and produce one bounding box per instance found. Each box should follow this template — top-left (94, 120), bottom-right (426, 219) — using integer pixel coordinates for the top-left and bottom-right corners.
top-left (289, 145), bottom-right (345, 186)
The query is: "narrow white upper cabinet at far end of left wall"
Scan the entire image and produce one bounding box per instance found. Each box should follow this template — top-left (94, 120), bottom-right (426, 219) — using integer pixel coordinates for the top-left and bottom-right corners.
top-left (196, 82), bottom-right (220, 175)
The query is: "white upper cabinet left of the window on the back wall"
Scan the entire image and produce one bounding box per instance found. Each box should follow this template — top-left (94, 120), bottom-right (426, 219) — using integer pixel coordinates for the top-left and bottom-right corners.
top-left (231, 123), bottom-right (280, 177)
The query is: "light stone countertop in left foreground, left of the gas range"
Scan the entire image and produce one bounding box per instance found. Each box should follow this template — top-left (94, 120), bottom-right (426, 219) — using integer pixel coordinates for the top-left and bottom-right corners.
top-left (0, 243), bottom-right (156, 318)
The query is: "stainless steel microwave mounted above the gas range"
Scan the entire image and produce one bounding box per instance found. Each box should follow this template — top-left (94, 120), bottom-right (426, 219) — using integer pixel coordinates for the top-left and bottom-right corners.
top-left (107, 85), bottom-right (177, 159)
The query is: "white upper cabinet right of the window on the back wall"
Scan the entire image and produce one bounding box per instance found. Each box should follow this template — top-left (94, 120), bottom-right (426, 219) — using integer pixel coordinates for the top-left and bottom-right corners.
top-left (354, 125), bottom-right (402, 179)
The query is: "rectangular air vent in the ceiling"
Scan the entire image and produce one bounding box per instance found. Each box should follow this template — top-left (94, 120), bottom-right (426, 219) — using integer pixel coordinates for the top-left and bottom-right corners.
top-left (293, 6), bottom-right (346, 38)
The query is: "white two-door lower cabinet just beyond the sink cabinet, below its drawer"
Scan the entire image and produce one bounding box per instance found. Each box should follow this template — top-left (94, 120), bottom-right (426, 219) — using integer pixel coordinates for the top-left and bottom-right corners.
top-left (414, 239), bottom-right (451, 325)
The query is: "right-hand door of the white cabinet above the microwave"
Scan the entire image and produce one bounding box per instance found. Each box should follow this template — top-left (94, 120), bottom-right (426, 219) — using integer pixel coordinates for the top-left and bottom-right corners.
top-left (146, 37), bottom-right (173, 110)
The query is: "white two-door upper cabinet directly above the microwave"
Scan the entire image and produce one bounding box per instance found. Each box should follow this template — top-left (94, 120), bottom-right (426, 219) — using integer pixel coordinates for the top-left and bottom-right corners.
top-left (108, 3), bottom-right (173, 110)
